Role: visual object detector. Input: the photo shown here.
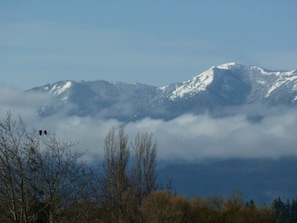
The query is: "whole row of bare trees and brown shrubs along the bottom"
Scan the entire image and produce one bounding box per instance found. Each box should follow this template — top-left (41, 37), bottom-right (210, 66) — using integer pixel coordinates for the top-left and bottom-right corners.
top-left (0, 114), bottom-right (297, 223)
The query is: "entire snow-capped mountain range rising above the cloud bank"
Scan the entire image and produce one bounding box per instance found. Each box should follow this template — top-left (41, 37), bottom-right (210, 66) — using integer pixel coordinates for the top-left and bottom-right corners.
top-left (30, 63), bottom-right (297, 120)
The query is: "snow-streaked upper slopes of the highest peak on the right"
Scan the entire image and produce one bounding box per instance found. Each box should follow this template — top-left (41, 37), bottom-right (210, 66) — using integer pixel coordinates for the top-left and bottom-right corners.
top-left (169, 62), bottom-right (297, 103)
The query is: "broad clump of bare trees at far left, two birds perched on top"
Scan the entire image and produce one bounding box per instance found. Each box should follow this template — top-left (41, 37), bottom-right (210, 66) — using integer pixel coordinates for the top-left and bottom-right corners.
top-left (0, 113), bottom-right (93, 223)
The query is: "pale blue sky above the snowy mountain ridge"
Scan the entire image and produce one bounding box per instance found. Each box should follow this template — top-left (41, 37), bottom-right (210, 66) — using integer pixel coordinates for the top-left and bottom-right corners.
top-left (0, 0), bottom-right (297, 89)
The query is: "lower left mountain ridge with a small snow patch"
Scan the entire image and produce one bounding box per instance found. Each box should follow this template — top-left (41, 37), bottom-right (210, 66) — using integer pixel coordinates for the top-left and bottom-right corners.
top-left (30, 81), bottom-right (159, 120)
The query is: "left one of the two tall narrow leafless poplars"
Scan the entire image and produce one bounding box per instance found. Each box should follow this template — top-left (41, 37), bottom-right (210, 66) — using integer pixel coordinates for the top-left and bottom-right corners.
top-left (101, 128), bottom-right (130, 222)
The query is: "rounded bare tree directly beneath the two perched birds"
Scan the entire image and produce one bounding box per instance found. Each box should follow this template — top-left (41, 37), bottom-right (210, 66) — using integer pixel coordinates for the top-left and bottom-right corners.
top-left (31, 136), bottom-right (87, 223)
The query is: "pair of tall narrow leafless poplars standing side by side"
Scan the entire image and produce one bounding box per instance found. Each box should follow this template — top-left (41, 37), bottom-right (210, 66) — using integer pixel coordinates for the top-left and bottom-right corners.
top-left (101, 128), bottom-right (157, 222)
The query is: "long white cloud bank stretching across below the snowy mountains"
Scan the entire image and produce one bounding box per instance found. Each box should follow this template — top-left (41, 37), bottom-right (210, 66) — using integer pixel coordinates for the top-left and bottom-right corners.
top-left (0, 87), bottom-right (297, 161)
